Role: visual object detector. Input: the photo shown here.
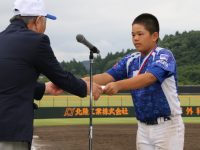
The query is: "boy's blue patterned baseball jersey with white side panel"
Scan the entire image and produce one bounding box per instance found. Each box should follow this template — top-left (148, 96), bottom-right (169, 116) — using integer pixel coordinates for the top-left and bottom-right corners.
top-left (107, 47), bottom-right (182, 121)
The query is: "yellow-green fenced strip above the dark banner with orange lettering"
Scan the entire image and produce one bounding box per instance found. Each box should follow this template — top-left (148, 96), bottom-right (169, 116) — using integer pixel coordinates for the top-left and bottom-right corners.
top-left (35, 95), bottom-right (200, 107)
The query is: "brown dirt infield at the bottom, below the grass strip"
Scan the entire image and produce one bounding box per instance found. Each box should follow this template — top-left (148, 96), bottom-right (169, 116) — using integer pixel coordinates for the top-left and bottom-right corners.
top-left (32, 124), bottom-right (200, 150)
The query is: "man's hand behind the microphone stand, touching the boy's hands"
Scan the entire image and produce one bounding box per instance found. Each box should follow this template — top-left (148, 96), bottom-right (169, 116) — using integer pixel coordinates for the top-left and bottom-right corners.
top-left (85, 81), bottom-right (103, 100)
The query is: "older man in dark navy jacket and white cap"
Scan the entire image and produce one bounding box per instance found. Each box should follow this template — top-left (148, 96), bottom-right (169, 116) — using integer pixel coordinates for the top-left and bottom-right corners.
top-left (0, 0), bottom-right (102, 150)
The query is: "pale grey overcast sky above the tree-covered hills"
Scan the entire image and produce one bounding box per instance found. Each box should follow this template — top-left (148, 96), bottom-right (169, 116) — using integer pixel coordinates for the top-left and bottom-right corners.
top-left (0, 0), bottom-right (200, 61)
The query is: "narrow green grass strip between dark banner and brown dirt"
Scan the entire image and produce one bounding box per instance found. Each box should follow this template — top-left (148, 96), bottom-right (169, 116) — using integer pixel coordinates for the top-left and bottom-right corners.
top-left (34, 117), bottom-right (200, 126)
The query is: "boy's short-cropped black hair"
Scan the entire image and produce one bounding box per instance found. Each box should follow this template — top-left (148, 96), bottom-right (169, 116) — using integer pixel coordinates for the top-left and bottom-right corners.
top-left (132, 13), bottom-right (160, 34)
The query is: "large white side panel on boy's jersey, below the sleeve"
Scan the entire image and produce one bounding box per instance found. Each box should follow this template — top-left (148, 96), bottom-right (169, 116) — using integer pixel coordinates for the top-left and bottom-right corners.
top-left (161, 76), bottom-right (182, 116)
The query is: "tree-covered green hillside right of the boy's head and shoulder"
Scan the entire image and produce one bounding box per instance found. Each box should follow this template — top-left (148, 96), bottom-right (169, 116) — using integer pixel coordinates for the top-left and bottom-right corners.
top-left (160, 31), bottom-right (200, 85)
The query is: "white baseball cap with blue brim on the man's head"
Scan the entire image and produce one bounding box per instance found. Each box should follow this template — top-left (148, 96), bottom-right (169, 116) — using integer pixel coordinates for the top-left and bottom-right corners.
top-left (14, 0), bottom-right (56, 20)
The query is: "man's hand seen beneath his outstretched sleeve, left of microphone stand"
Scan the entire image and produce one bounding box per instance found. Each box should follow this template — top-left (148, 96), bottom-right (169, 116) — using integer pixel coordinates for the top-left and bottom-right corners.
top-left (45, 82), bottom-right (64, 95)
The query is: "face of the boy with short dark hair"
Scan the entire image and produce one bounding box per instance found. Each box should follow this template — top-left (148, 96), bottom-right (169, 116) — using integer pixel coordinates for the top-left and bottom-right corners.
top-left (132, 24), bottom-right (158, 55)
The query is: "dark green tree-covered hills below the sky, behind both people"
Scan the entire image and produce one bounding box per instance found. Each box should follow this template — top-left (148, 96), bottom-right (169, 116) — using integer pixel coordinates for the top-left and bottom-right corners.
top-left (39, 31), bottom-right (200, 85)
